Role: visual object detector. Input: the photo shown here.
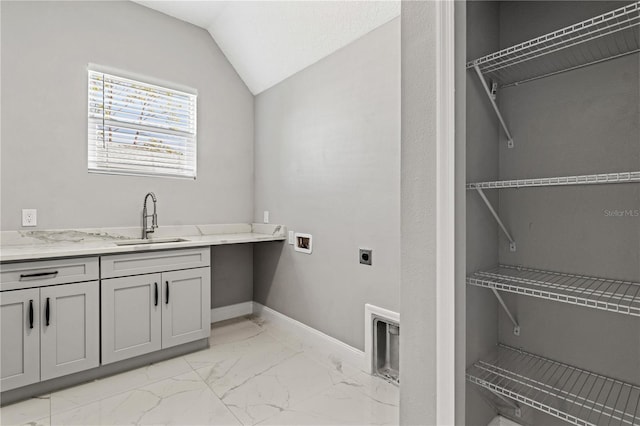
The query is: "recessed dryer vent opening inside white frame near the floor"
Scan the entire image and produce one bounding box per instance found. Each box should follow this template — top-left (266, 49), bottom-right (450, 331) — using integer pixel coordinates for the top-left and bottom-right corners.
top-left (372, 315), bottom-right (400, 384)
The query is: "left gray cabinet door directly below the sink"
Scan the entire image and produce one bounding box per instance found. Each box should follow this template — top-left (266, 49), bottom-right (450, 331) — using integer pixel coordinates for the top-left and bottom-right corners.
top-left (100, 274), bottom-right (162, 364)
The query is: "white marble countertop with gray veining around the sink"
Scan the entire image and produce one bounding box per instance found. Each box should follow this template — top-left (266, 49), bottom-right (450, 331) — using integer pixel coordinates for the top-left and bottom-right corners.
top-left (0, 223), bottom-right (287, 262)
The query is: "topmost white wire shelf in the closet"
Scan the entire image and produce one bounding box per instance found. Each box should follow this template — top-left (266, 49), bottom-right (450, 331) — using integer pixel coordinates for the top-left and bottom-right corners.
top-left (467, 1), bottom-right (640, 87)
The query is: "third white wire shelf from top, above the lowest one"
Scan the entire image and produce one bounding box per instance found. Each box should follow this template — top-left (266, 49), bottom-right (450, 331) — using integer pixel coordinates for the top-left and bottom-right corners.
top-left (467, 265), bottom-right (640, 317)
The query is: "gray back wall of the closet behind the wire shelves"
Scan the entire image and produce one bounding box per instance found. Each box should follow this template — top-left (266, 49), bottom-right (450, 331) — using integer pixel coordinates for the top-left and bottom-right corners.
top-left (499, 2), bottom-right (640, 424)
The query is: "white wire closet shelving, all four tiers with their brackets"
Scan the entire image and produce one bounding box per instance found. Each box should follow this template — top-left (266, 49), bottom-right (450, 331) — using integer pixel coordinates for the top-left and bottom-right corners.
top-left (466, 1), bottom-right (640, 426)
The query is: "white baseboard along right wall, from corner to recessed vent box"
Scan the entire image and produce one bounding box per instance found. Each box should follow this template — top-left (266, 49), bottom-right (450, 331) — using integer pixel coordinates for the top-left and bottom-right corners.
top-left (253, 302), bottom-right (366, 371)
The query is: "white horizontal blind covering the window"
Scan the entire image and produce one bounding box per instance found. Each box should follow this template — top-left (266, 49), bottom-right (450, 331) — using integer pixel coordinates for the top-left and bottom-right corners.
top-left (88, 70), bottom-right (197, 179)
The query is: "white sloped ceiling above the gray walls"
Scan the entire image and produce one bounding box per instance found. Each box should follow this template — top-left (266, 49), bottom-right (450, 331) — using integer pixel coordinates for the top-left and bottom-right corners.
top-left (133, 0), bottom-right (400, 95)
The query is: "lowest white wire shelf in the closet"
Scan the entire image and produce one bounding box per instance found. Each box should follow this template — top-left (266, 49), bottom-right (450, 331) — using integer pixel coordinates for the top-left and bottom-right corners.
top-left (467, 344), bottom-right (640, 426)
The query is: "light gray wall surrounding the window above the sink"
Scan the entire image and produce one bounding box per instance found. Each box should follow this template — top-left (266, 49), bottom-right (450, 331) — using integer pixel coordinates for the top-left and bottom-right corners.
top-left (1, 1), bottom-right (253, 230)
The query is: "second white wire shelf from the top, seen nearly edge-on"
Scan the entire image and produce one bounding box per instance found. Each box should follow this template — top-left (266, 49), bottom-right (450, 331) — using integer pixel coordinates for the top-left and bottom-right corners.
top-left (467, 171), bottom-right (640, 189)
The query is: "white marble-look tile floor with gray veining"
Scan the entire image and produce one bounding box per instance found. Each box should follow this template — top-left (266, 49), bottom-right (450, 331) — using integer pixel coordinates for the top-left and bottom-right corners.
top-left (0, 317), bottom-right (399, 426)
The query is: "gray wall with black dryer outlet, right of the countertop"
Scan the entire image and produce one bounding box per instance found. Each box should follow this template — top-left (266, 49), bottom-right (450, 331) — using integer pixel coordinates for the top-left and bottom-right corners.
top-left (254, 19), bottom-right (400, 349)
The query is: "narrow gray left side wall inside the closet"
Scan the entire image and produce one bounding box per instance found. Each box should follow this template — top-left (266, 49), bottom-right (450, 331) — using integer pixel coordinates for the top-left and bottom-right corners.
top-left (466, 2), bottom-right (504, 425)
